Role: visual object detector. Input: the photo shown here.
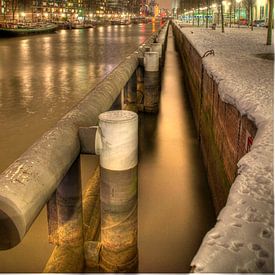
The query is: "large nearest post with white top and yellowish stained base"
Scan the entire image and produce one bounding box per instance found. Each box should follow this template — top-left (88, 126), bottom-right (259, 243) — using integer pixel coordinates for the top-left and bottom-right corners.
top-left (99, 111), bottom-right (138, 272)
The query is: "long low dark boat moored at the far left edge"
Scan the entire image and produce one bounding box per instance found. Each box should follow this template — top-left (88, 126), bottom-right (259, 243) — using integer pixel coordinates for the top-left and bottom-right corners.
top-left (0, 24), bottom-right (58, 37)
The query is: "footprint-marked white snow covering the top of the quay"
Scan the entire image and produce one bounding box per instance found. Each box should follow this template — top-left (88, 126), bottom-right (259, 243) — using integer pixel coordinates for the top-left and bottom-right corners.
top-left (175, 22), bottom-right (274, 273)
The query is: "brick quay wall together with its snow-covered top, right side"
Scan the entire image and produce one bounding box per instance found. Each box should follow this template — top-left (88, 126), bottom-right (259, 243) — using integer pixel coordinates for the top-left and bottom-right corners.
top-left (173, 21), bottom-right (274, 273)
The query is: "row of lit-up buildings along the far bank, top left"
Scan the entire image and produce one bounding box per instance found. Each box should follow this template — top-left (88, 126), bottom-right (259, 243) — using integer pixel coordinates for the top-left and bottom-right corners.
top-left (0, 0), bottom-right (141, 21)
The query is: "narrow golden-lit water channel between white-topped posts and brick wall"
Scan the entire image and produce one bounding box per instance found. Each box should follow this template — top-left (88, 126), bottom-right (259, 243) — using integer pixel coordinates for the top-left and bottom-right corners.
top-left (138, 29), bottom-right (215, 273)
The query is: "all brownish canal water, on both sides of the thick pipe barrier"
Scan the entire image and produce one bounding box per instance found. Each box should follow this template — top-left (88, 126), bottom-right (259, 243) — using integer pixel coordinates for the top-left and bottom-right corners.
top-left (0, 24), bottom-right (218, 273)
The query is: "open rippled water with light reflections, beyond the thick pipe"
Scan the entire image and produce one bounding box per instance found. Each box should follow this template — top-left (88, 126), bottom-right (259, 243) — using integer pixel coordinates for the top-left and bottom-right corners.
top-left (0, 24), bottom-right (157, 172)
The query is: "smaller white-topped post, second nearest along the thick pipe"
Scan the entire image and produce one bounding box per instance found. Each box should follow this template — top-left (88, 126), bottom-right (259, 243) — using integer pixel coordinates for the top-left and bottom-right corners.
top-left (144, 52), bottom-right (160, 113)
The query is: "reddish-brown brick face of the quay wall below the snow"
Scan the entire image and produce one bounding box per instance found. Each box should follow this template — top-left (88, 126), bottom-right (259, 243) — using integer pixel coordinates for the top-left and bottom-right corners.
top-left (173, 24), bottom-right (257, 214)
